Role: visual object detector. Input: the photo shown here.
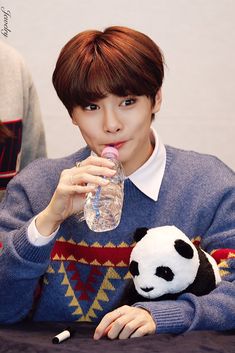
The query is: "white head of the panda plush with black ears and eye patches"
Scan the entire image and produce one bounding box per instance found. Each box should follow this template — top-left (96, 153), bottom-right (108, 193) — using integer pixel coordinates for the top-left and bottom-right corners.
top-left (129, 226), bottom-right (200, 299)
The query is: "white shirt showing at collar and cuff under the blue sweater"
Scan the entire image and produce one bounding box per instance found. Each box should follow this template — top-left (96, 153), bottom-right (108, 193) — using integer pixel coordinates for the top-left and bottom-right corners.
top-left (28, 127), bottom-right (166, 246)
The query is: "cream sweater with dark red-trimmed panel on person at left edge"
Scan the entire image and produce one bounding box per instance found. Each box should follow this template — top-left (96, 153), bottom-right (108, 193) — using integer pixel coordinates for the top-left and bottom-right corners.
top-left (0, 41), bottom-right (46, 199)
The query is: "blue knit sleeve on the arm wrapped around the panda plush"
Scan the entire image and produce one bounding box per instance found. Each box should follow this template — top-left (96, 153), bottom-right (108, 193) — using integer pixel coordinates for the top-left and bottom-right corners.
top-left (134, 176), bottom-right (235, 333)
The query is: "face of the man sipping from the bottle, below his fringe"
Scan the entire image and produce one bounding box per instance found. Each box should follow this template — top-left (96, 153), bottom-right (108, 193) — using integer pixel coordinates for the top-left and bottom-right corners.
top-left (72, 90), bottom-right (161, 175)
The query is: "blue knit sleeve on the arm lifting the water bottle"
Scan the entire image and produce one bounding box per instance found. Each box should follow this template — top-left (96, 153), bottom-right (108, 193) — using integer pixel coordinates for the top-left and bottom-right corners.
top-left (0, 175), bottom-right (54, 323)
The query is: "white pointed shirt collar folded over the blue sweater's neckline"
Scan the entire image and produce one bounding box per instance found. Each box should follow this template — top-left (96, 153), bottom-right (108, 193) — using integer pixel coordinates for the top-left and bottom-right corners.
top-left (128, 127), bottom-right (166, 201)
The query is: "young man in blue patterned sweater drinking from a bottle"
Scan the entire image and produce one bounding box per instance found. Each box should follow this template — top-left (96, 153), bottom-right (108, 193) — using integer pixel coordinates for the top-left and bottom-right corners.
top-left (0, 27), bottom-right (235, 339)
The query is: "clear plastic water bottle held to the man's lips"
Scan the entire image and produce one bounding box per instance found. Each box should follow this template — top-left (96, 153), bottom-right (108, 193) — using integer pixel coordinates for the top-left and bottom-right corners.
top-left (84, 146), bottom-right (124, 232)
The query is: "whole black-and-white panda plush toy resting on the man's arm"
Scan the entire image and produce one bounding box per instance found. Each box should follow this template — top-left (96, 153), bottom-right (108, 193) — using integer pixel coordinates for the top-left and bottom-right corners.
top-left (122, 226), bottom-right (221, 305)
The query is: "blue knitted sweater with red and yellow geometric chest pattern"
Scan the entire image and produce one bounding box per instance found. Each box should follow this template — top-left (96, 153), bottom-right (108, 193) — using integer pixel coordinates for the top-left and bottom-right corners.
top-left (0, 146), bottom-right (235, 333)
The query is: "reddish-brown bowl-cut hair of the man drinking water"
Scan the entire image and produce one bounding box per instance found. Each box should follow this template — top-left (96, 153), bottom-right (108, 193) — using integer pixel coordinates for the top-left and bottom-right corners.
top-left (52, 26), bottom-right (164, 115)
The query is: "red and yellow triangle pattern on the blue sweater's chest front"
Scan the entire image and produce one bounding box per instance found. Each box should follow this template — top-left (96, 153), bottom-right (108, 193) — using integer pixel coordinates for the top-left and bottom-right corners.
top-left (44, 237), bottom-right (134, 321)
